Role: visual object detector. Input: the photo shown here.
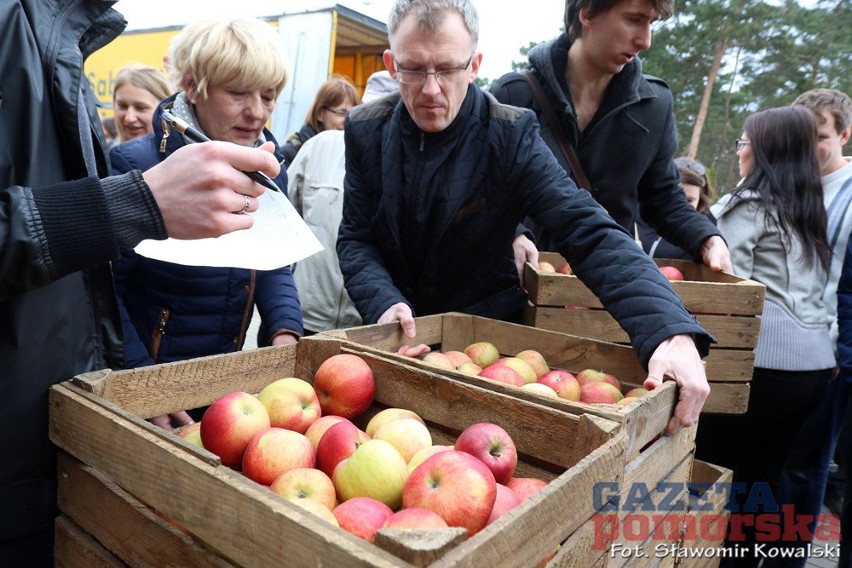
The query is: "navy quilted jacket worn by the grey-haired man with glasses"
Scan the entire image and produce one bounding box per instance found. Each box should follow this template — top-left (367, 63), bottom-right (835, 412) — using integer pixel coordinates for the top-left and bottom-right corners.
top-left (337, 86), bottom-right (710, 364)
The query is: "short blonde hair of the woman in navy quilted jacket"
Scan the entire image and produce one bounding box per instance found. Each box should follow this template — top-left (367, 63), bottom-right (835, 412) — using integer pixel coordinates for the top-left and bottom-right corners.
top-left (167, 18), bottom-right (288, 100)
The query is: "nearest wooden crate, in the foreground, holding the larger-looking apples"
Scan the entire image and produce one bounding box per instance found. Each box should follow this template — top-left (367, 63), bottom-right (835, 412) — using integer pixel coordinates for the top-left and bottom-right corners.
top-left (50, 337), bottom-right (627, 568)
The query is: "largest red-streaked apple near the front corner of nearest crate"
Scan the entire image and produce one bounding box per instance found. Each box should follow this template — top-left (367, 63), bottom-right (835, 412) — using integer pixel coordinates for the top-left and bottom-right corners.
top-left (402, 450), bottom-right (497, 536)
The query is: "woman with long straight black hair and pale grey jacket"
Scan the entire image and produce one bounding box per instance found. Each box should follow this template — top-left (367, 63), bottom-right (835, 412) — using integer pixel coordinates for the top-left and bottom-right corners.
top-left (696, 106), bottom-right (835, 566)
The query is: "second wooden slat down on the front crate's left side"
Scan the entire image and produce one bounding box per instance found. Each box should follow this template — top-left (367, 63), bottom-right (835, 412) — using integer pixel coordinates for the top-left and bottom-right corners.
top-left (57, 452), bottom-right (231, 568)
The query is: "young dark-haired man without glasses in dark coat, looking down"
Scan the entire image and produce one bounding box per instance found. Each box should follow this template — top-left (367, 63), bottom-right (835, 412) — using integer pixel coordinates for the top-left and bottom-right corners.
top-left (489, 0), bottom-right (732, 272)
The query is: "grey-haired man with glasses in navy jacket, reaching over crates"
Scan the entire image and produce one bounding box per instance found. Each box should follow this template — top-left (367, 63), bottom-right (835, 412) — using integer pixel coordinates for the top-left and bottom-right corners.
top-left (337, 0), bottom-right (710, 431)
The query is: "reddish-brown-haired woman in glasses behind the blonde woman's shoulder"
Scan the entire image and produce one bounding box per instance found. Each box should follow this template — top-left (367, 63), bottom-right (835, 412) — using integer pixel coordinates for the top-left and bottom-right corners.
top-left (281, 75), bottom-right (361, 167)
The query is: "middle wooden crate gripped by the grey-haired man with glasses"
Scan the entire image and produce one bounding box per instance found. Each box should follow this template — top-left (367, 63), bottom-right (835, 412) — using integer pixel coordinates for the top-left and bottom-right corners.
top-left (325, 313), bottom-right (677, 461)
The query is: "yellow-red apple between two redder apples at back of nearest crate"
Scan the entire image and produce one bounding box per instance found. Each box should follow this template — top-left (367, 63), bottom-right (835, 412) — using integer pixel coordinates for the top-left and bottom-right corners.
top-left (257, 377), bottom-right (322, 434)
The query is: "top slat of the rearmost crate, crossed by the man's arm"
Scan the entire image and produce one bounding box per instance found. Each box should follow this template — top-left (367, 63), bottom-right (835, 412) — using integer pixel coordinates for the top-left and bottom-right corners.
top-left (524, 252), bottom-right (766, 316)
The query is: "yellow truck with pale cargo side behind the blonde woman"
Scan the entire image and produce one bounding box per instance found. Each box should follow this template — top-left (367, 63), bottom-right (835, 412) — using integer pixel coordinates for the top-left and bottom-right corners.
top-left (86, 1), bottom-right (388, 142)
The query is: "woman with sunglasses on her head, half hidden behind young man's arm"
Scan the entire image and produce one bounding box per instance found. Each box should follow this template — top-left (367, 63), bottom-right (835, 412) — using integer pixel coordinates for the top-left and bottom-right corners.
top-left (636, 158), bottom-right (716, 260)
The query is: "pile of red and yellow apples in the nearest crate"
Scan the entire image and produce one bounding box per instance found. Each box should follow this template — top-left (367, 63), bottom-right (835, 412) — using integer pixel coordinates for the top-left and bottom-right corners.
top-left (178, 354), bottom-right (547, 542)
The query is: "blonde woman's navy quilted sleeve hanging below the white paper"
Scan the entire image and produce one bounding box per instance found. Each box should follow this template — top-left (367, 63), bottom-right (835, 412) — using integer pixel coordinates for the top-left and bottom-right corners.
top-left (255, 266), bottom-right (304, 345)
